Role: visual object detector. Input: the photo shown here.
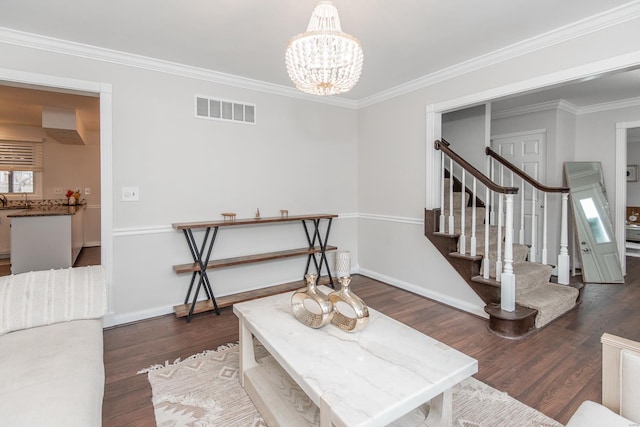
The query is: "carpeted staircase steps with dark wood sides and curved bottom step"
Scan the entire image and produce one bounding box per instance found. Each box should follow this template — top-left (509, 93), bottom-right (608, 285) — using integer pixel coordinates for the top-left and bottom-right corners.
top-left (425, 140), bottom-right (582, 338)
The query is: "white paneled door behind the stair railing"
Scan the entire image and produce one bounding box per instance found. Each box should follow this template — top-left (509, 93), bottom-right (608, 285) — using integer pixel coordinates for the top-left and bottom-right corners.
top-left (491, 130), bottom-right (547, 262)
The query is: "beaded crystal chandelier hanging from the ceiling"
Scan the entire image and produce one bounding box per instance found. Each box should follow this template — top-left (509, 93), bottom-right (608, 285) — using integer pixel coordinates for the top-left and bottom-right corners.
top-left (285, 1), bottom-right (363, 95)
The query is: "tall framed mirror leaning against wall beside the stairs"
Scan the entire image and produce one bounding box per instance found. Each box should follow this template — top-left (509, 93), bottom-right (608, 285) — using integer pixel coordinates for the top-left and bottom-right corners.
top-left (564, 162), bottom-right (624, 283)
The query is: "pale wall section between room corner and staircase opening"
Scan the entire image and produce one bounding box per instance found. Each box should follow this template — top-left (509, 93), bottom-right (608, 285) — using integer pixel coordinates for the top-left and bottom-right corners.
top-left (358, 92), bottom-right (484, 316)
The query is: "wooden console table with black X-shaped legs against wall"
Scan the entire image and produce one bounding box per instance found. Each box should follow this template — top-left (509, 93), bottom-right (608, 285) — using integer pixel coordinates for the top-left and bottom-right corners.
top-left (172, 214), bottom-right (338, 322)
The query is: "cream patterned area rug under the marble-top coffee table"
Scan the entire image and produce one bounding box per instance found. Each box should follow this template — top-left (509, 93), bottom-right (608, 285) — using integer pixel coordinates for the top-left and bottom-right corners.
top-left (139, 344), bottom-right (562, 427)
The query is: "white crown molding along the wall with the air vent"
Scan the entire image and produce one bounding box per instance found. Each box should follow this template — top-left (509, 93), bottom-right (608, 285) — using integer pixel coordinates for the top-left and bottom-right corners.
top-left (0, 27), bottom-right (357, 109)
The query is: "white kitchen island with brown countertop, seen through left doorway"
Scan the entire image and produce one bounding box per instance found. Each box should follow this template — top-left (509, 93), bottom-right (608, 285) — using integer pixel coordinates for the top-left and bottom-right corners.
top-left (9, 206), bottom-right (84, 274)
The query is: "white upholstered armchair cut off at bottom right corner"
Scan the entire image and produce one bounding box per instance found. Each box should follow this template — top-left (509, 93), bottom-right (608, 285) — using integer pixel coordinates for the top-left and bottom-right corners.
top-left (567, 334), bottom-right (640, 427)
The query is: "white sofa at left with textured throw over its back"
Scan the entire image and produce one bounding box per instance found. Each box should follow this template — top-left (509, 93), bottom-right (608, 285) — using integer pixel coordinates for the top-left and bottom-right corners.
top-left (0, 266), bottom-right (106, 427)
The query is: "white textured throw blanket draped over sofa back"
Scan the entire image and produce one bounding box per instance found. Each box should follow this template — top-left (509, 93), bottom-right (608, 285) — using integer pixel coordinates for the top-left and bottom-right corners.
top-left (0, 265), bottom-right (107, 335)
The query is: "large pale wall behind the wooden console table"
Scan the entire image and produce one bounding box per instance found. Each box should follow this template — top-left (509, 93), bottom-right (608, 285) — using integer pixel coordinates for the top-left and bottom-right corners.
top-left (0, 44), bottom-right (358, 323)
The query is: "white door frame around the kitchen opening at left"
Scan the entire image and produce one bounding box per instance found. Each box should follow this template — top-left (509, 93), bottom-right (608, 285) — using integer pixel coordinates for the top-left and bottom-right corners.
top-left (0, 68), bottom-right (113, 315)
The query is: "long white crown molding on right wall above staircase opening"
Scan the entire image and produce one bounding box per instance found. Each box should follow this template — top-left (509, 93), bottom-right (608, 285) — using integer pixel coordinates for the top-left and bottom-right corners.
top-left (358, 0), bottom-right (640, 108)
